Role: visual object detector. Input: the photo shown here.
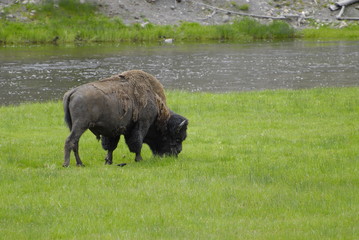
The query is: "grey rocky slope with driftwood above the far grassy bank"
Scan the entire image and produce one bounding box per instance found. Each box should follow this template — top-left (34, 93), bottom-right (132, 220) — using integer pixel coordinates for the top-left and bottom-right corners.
top-left (0, 0), bottom-right (359, 28)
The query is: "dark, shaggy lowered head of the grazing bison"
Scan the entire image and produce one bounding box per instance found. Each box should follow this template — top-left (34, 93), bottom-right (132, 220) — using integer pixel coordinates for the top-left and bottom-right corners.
top-left (145, 112), bottom-right (188, 157)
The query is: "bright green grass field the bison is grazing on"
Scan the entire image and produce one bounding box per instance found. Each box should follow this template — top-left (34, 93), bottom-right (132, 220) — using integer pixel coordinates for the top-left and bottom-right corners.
top-left (0, 88), bottom-right (359, 240)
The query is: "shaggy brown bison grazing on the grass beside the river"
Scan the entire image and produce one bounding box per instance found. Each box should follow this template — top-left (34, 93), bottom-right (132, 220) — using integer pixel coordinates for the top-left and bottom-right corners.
top-left (63, 70), bottom-right (188, 167)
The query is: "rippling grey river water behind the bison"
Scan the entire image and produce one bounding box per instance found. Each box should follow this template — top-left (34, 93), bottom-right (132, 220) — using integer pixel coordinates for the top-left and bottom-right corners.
top-left (0, 41), bottom-right (359, 105)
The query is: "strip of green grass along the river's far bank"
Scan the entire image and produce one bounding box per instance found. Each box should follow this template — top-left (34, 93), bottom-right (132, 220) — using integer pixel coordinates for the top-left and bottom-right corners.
top-left (0, 0), bottom-right (359, 44)
